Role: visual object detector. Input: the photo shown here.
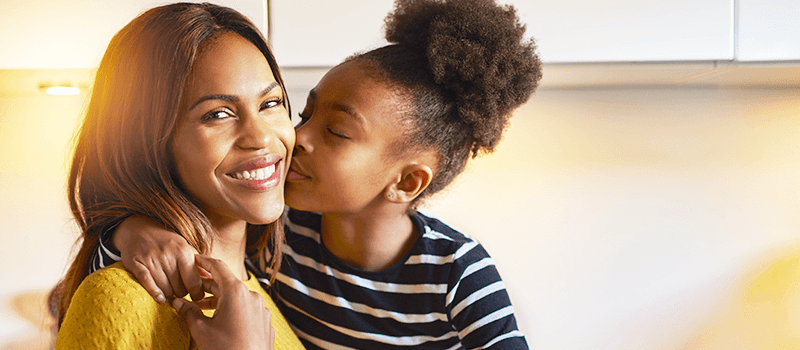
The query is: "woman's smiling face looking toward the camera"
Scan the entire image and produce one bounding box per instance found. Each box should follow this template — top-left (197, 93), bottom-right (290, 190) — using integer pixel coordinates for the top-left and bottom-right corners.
top-left (172, 33), bottom-right (295, 225)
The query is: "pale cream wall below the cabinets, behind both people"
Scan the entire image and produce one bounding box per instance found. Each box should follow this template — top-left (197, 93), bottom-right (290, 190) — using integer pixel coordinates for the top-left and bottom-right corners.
top-left (0, 78), bottom-right (800, 350)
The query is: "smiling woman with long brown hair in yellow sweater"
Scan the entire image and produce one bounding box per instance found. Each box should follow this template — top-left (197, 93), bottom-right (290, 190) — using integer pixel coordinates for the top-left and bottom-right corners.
top-left (51, 3), bottom-right (302, 349)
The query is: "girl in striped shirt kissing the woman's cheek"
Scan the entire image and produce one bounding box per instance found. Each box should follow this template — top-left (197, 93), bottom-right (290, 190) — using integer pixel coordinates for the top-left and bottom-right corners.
top-left (98, 0), bottom-right (541, 349)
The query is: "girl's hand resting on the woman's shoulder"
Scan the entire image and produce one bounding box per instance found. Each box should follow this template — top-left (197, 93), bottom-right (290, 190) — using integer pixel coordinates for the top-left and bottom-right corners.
top-left (112, 215), bottom-right (204, 303)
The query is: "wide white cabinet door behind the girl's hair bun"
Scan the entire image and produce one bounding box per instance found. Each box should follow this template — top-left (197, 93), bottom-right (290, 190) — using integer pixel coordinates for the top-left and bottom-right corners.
top-left (270, 0), bottom-right (736, 66)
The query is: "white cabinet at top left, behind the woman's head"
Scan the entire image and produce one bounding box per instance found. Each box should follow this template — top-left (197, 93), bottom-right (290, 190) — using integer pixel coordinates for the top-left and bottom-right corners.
top-left (0, 0), bottom-right (267, 69)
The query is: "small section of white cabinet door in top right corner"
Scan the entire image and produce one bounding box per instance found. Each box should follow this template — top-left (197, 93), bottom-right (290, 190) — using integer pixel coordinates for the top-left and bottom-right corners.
top-left (737, 0), bottom-right (800, 61)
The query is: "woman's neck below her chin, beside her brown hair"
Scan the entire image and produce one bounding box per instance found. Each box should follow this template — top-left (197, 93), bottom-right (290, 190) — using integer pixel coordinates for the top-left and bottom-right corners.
top-left (208, 220), bottom-right (248, 280)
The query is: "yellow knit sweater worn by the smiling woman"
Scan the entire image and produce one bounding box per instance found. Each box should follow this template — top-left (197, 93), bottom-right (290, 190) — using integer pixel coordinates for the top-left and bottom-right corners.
top-left (56, 263), bottom-right (303, 349)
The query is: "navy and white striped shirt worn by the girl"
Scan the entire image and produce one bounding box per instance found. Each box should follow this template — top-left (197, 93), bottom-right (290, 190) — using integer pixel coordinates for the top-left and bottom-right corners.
top-left (92, 209), bottom-right (528, 349)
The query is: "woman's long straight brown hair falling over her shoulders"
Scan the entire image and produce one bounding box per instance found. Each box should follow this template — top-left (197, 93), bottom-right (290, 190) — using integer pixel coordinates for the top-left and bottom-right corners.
top-left (50, 3), bottom-right (289, 326)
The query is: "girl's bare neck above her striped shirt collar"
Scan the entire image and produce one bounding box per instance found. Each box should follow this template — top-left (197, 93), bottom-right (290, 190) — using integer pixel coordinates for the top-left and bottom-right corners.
top-left (321, 211), bottom-right (418, 271)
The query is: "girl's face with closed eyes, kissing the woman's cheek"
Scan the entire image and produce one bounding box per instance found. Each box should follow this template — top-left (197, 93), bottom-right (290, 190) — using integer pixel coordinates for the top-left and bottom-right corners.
top-left (286, 62), bottom-right (404, 213)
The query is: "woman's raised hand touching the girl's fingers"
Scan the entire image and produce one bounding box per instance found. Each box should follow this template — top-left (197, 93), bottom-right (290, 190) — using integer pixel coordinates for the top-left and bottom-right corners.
top-left (172, 255), bottom-right (275, 350)
